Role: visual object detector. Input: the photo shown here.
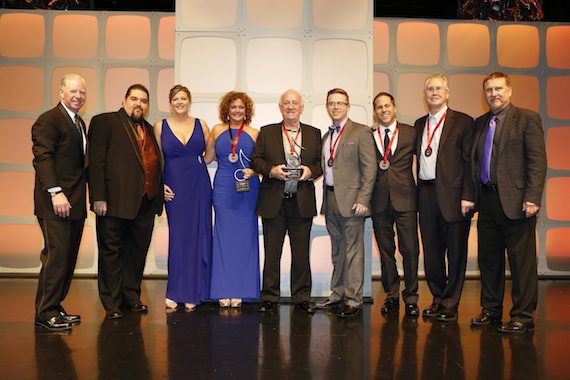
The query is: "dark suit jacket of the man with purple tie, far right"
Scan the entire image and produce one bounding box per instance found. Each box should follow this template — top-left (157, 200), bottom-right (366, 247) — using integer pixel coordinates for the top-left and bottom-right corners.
top-left (471, 105), bottom-right (547, 219)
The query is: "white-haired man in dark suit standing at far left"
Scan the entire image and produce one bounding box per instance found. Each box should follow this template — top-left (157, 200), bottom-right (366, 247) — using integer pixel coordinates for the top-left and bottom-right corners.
top-left (32, 74), bottom-right (87, 331)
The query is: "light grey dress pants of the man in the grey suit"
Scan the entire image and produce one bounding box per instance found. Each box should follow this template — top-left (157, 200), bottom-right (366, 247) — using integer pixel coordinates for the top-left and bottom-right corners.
top-left (325, 190), bottom-right (365, 307)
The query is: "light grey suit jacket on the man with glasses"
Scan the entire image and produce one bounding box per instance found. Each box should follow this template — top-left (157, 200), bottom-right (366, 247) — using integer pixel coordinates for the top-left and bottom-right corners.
top-left (321, 119), bottom-right (377, 218)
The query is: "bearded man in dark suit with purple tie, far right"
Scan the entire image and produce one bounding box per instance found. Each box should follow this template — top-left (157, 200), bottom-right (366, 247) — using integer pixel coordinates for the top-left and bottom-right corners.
top-left (471, 72), bottom-right (547, 333)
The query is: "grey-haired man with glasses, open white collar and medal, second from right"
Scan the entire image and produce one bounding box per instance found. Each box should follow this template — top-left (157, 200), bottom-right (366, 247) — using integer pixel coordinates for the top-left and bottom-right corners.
top-left (415, 74), bottom-right (475, 322)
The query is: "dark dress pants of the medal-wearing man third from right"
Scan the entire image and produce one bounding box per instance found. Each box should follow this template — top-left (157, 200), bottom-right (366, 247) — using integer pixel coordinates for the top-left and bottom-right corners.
top-left (372, 202), bottom-right (419, 304)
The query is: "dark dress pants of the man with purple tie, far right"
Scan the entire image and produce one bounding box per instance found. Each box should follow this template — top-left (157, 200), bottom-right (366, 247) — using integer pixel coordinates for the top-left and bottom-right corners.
top-left (477, 189), bottom-right (538, 323)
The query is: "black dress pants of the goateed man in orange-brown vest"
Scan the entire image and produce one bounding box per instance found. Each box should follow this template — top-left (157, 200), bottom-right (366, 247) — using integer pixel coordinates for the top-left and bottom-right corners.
top-left (97, 196), bottom-right (155, 310)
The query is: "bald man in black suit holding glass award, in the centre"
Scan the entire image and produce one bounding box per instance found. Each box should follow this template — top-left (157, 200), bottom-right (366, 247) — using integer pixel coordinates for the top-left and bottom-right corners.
top-left (251, 90), bottom-right (322, 314)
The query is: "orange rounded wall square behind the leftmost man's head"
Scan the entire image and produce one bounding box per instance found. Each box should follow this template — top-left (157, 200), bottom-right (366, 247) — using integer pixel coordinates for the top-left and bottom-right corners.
top-left (51, 66), bottom-right (99, 115)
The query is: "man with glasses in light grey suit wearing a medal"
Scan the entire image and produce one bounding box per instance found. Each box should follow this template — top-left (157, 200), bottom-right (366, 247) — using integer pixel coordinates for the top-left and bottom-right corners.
top-left (318, 88), bottom-right (376, 318)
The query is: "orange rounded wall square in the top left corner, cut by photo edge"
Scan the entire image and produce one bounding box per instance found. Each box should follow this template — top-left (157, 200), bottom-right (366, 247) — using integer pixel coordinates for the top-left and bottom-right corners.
top-left (0, 13), bottom-right (46, 58)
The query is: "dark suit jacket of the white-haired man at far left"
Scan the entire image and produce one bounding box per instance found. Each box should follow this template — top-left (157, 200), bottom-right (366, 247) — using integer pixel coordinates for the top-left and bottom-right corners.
top-left (32, 103), bottom-right (87, 220)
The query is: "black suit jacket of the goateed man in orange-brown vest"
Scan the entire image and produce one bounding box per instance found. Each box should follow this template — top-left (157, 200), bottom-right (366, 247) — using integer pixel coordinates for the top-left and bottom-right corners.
top-left (89, 108), bottom-right (164, 220)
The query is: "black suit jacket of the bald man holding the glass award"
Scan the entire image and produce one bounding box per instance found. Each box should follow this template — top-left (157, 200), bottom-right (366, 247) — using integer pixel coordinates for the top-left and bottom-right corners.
top-left (251, 123), bottom-right (323, 218)
